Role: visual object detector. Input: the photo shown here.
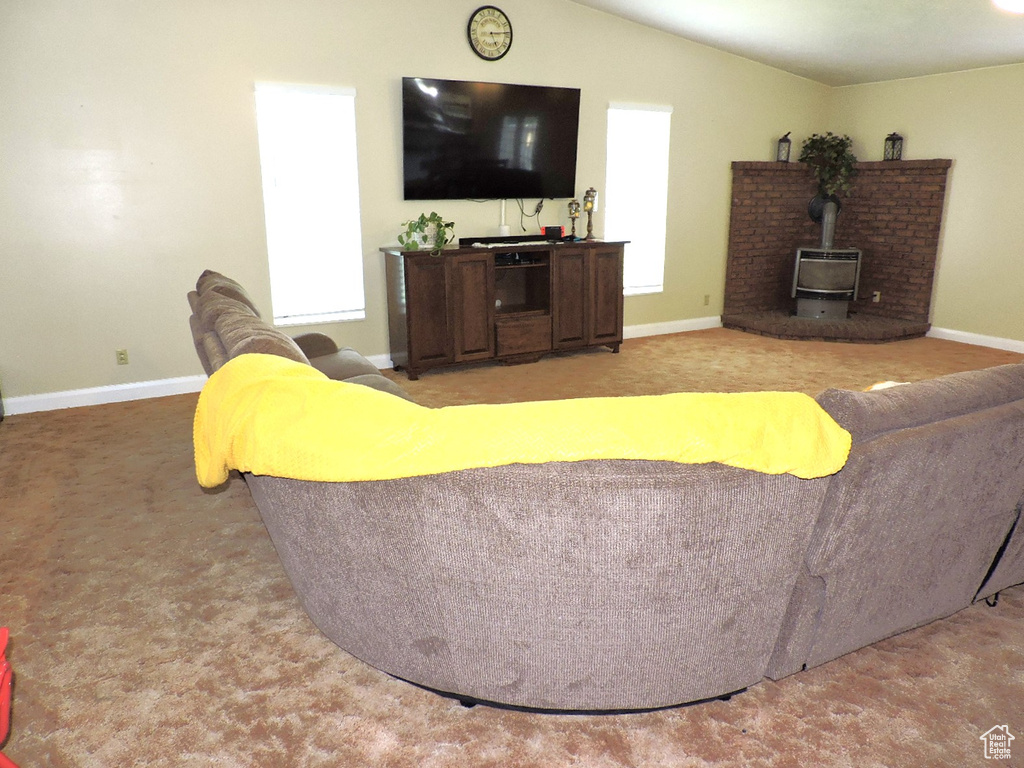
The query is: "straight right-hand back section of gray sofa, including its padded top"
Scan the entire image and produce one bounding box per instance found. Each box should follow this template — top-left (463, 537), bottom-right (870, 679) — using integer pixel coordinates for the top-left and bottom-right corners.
top-left (768, 365), bottom-right (1024, 679)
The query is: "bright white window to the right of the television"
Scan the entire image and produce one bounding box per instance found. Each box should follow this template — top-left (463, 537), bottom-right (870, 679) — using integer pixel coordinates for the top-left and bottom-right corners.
top-left (604, 104), bottom-right (672, 296)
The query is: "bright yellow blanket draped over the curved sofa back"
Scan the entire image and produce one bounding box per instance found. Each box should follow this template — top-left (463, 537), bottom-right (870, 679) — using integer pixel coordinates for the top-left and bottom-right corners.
top-left (194, 354), bottom-right (850, 487)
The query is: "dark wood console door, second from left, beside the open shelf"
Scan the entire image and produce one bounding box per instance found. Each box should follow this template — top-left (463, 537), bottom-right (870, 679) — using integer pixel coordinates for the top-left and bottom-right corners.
top-left (447, 254), bottom-right (495, 361)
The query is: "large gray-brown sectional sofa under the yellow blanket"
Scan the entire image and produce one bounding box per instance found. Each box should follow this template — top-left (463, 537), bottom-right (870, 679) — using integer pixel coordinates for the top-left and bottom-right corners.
top-left (190, 273), bottom-right (1024, 711)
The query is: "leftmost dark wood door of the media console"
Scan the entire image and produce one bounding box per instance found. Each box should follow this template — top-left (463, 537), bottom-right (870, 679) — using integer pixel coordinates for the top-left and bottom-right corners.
top-left (404, 254), bottom-right (452, 372)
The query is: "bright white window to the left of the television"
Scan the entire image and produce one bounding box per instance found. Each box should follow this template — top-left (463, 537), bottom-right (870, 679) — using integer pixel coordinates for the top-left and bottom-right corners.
top-left (256, 83), bottom-right (366, 326)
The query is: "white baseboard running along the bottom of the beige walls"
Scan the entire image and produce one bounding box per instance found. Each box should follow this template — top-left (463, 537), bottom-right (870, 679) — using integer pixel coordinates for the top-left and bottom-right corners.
top-left (3, 323), bottom-right (1024, 416)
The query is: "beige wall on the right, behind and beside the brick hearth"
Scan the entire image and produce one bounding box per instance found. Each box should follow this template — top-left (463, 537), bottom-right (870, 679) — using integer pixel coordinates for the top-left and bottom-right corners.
top-left (831, 65), bottom-right (1024, 341)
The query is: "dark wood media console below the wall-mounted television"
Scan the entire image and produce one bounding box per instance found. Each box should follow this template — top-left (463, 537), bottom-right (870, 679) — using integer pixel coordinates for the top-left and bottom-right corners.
top-left (381, 241), bottom-right (625, 379)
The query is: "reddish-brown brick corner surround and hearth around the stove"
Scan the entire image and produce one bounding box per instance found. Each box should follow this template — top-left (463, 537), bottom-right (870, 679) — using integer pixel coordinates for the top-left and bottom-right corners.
top-left (722, 160), bottom-right (952, 342)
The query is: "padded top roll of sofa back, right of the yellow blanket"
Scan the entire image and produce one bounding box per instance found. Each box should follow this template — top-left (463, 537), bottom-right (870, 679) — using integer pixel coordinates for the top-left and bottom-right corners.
top-left (816, 364), bottom-right (1024, 442)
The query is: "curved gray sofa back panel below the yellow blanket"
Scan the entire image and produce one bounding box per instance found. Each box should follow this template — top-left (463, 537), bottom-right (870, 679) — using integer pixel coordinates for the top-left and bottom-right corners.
top-left (247, 461), bottom-right (827, 710)
